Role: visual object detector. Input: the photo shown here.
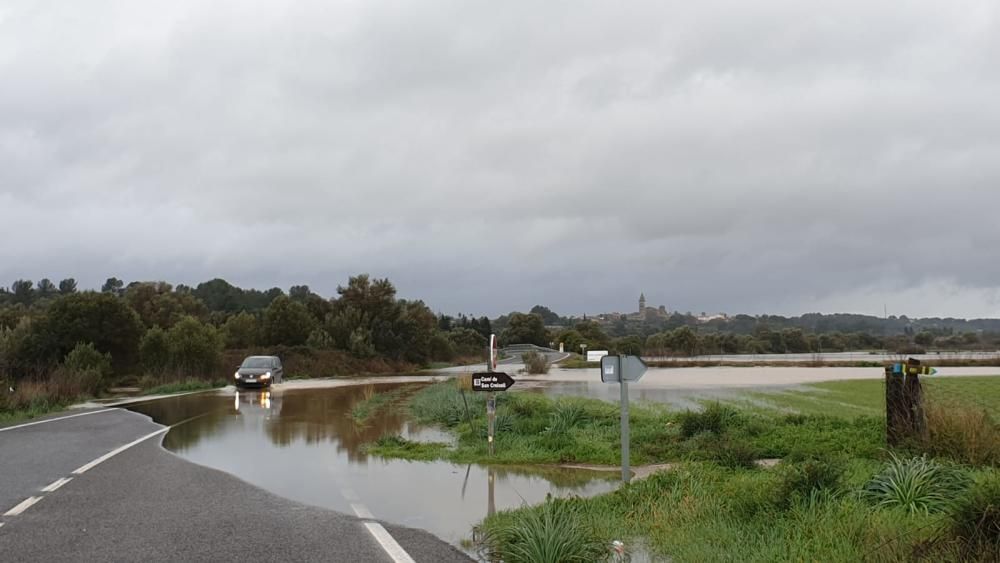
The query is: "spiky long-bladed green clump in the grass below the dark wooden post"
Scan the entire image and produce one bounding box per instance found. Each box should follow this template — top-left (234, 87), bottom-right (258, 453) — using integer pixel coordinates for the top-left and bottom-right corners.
top-left (864, 453), bottom-right (968, 514)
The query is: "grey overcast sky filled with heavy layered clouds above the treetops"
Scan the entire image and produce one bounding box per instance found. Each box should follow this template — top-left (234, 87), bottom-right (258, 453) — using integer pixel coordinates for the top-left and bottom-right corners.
top-left (0, 0), bottom-right (1000, 317)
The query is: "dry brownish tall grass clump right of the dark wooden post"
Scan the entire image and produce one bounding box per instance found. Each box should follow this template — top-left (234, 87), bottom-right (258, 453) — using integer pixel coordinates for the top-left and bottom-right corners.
top-left (919, 401), bottom-right (1000, 466)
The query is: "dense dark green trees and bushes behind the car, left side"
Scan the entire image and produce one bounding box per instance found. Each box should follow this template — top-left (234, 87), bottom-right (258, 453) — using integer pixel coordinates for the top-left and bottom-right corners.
top-left (0, 274), bottom-right (491, 388)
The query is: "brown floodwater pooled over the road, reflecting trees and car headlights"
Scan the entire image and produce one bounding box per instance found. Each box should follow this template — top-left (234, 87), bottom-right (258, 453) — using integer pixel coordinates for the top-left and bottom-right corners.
top-left (127, 383), bottom-right (618, 545)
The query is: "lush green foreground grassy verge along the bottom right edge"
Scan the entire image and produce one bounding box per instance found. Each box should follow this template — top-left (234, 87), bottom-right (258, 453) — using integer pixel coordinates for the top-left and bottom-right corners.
top-left (480, 460), bottom-right (998, 562)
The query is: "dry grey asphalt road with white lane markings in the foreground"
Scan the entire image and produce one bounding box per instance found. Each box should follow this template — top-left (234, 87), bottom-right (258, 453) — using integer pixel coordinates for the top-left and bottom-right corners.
top-left (0, 409), bottom-right (469, 562)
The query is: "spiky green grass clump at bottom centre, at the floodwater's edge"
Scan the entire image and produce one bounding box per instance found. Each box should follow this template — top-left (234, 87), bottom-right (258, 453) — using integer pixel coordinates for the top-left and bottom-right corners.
top-left (481, 498), bottom-right (608, 563)
